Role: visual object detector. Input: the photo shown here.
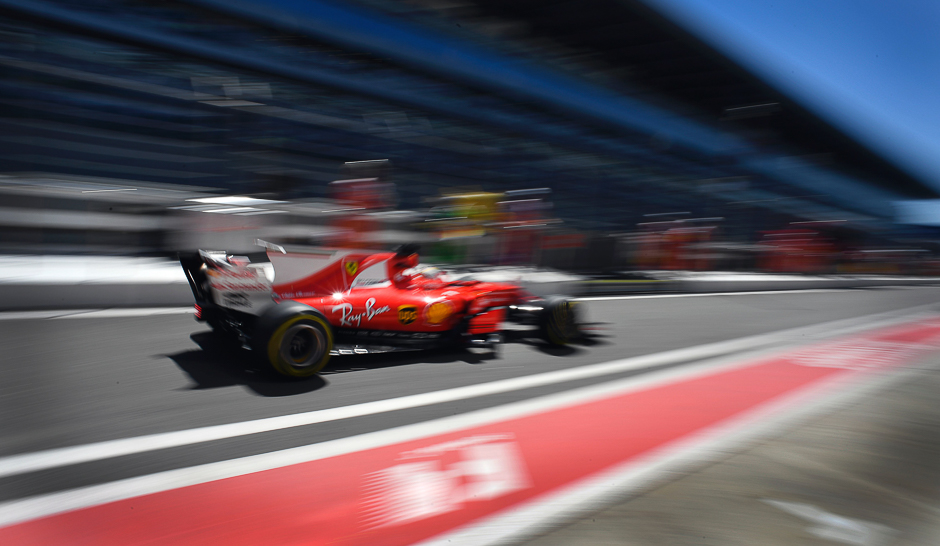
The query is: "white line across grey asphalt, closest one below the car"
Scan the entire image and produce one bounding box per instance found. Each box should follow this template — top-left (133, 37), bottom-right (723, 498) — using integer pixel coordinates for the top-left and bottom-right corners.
top-left (0, 304), bottom-right (933, 477)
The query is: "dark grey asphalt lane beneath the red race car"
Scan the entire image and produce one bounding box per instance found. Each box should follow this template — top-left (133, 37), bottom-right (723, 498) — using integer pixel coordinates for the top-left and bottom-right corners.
top-left (0, 288), bottom-right (940, 540)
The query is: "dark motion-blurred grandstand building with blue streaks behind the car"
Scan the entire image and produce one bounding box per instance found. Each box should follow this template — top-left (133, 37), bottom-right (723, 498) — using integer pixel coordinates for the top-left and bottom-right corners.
top-left (0, 0), bottom-right (932, 234)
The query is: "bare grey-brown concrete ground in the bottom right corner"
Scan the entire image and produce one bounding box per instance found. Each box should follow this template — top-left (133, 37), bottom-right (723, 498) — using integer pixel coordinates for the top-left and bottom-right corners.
top-left (525, 344), bottom-right (940, 546)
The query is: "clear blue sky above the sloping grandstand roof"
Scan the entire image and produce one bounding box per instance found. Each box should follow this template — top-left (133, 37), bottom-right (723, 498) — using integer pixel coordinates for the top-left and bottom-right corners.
top-left (646, 0), bottom-right (940, 192)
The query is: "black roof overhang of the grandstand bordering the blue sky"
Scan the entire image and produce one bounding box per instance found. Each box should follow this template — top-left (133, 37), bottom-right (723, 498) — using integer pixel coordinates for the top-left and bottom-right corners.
top-left (370, 0), bottom-right (935, 197)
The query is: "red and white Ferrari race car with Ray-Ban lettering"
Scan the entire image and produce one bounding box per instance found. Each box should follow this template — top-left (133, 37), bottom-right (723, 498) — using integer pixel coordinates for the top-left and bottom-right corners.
top-left (180, 243), bottom-right (580, 377)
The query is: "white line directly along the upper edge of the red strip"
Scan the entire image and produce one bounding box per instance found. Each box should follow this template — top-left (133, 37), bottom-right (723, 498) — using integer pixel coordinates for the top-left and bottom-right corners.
top-left (0, 340), bottom-right (852, 527)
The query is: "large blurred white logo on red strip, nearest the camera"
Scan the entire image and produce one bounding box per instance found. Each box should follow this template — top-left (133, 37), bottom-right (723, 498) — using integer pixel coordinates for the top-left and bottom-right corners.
top-left (362, 434), bottom-right (530, 529)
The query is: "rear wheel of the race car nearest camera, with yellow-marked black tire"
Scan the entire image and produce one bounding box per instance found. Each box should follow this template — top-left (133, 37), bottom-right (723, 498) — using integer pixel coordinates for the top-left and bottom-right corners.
top-left (254, 302), bottom-right (333, 378)
